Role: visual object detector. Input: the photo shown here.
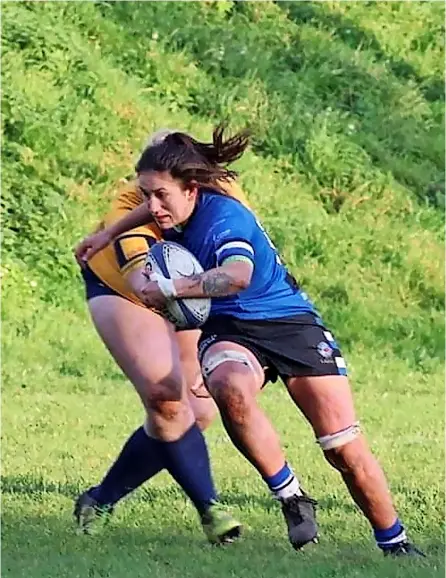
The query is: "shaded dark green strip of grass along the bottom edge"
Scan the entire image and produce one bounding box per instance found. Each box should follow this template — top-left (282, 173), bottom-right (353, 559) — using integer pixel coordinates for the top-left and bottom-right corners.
top-left (2, 501), bottom-right (444, 578)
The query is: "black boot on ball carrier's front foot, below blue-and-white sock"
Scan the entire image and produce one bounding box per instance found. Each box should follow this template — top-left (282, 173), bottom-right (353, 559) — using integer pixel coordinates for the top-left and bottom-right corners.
top-left (280, 493), bottom-right (318, 550)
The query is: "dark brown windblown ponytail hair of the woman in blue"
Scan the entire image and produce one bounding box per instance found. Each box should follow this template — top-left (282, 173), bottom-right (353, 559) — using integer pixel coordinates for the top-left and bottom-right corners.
top-left (135, 125), bottom-right (249, 192)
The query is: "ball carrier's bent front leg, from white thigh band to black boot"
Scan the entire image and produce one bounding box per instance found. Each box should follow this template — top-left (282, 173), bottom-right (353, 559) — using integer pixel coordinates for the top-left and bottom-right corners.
top-left (201, 341), bottom-right (317, 550)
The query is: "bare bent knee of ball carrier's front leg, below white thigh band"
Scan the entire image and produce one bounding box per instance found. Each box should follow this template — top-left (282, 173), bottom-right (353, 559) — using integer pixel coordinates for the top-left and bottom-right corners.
top-left (208, 376), bottom-right (254, 425)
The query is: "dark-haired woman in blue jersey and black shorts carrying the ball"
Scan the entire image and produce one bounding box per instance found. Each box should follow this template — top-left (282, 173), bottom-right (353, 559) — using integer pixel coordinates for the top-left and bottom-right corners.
top-left (128, 127), bottom-right (423, 556)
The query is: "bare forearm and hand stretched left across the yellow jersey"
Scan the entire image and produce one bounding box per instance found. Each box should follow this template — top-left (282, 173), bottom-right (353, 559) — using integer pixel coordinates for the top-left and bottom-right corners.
top-left (74, 203), bottom-right (153, 267)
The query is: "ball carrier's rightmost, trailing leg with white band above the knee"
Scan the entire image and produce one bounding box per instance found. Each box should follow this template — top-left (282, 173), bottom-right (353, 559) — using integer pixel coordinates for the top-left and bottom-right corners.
top-left (287, 375), bottom-right (423, 555)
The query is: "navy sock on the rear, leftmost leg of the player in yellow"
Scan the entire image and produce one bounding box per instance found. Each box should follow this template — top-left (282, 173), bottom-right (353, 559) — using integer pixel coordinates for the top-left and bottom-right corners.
top-left (90, 426), bottom-right (165, 505)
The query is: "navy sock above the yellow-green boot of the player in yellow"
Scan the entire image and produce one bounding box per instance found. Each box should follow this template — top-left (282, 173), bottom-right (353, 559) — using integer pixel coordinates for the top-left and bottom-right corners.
top-left (161, 423), bottom-right (217, 515)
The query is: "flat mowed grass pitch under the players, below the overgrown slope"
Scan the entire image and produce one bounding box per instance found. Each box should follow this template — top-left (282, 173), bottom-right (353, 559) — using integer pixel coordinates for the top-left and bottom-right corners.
top-left (2, 308), bottom-right (444, 578)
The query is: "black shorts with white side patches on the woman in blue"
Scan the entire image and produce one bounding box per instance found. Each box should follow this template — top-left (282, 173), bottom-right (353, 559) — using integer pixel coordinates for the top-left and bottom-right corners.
top-left (198, 313), bottom-right (347, 381)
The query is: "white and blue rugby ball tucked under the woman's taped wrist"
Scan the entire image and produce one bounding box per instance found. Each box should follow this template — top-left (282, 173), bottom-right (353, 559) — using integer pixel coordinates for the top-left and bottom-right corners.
top-left (145, 241), bottom-right (211, 329)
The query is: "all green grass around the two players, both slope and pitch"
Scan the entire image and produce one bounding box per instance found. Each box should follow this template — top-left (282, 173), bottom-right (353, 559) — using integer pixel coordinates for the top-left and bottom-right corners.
top-left (1, 2), bottom-right (444, 578)
